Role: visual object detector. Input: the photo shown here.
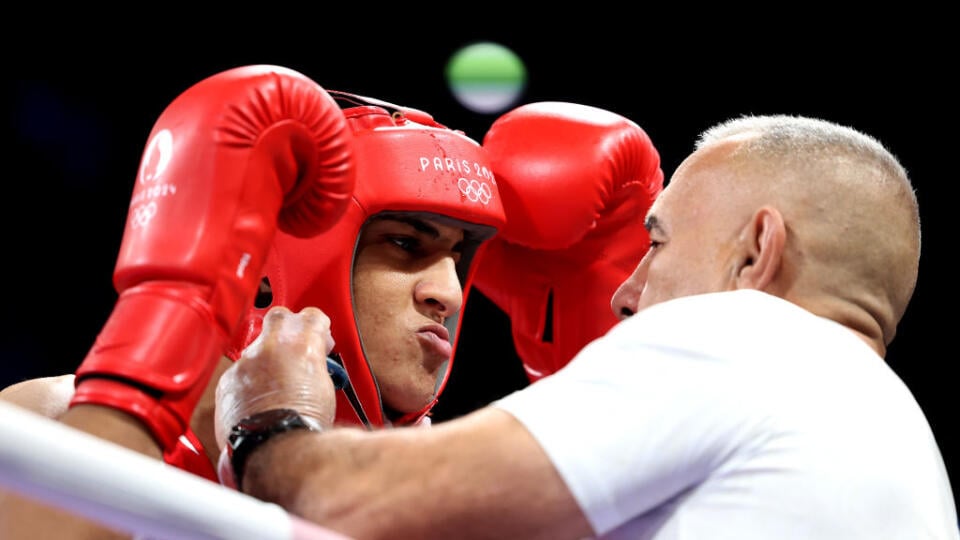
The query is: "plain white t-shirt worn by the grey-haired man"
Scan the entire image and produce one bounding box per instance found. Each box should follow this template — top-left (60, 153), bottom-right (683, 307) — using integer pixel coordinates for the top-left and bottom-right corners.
top-left (495, 290), bottom-right (960, 540)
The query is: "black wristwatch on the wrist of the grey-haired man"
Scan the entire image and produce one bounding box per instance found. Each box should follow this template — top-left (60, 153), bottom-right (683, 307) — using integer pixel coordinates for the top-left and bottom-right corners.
top-left (227, 409), bottom-right (323, 491)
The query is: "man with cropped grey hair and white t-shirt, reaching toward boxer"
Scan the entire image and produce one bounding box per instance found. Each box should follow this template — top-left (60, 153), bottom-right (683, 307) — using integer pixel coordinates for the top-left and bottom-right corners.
top-left (217, 112), bottom-right (958, 540)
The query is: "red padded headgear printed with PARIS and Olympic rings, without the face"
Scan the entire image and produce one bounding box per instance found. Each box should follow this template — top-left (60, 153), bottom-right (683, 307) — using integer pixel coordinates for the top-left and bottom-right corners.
top-left (229, 91), bottom-right (505, 427)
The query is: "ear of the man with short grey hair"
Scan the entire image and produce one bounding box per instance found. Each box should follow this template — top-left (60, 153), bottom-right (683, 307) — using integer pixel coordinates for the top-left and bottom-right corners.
top-left (737, 206), bottom-right (787, 291)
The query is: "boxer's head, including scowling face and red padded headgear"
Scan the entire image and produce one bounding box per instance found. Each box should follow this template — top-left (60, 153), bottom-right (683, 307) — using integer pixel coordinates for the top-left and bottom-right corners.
top-left (231, 91), bottom-right (504, 427)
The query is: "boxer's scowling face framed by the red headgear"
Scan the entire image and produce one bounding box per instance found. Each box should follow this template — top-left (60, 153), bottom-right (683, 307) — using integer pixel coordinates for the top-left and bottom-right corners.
top-left (353, 217), bottom-right (464, 413)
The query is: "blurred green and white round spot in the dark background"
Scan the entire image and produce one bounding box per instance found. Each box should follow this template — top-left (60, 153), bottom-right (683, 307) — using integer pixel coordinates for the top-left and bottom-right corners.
top-left (446, 41), bottom-right (527, 113)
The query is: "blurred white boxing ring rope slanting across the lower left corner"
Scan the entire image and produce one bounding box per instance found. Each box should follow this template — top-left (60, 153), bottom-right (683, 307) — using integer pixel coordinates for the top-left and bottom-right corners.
top-left (0, 401), bottom-right (346, 540)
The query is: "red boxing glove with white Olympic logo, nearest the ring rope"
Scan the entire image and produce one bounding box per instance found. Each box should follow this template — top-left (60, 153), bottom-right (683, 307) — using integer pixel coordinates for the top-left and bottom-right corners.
top-left (71, 66), bottom-right (355, 452)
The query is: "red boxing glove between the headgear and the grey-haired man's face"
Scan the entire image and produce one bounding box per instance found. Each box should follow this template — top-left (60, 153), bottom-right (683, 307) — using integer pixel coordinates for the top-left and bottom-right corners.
top-left (474, 102), bottom-right (663, 381)
